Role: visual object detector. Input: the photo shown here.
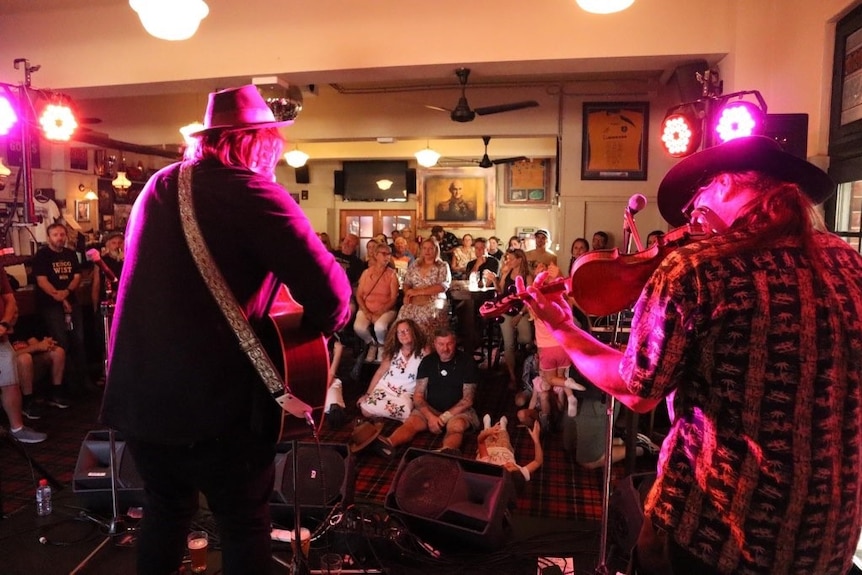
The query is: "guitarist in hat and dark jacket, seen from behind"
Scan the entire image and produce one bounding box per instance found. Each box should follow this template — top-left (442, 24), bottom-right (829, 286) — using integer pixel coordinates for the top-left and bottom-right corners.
top-left (101, 85), bottom-right (350, 575)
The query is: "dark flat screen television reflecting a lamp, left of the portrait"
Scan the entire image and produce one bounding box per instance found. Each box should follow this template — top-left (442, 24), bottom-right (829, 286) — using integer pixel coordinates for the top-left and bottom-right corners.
top-left (342, 160), bottom-right (407, 202)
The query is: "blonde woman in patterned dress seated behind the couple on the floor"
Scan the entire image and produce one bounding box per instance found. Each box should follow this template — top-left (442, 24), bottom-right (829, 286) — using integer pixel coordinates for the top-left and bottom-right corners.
top-left (398, 239), bottom-right (452, 337)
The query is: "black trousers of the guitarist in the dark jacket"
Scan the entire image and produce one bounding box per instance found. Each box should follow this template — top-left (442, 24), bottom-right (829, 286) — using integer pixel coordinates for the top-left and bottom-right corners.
top-left (127, 434), bottom-right (275, 575)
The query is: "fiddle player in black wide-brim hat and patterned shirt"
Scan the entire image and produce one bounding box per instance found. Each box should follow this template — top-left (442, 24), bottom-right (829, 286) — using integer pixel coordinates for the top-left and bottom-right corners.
top-left (526, 136), bottom-right (862, 575)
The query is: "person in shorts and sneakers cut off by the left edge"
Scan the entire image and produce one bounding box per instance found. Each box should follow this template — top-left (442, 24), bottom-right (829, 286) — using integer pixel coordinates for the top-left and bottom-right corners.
top-left (0, 267), bottom-right (48, 443)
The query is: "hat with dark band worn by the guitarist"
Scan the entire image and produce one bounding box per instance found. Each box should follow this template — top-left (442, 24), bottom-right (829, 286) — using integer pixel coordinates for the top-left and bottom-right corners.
top-left (189, 84), bottom-right (293, 137)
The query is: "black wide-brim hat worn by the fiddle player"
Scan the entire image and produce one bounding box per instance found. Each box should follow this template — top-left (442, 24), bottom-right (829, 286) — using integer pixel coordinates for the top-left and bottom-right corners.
top-left (658, 136), bottom-right (835, 227)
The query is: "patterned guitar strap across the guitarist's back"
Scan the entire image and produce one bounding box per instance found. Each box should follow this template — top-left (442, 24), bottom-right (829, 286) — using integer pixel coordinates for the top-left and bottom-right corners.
top-left (179, 162), bottom-right (290, 400)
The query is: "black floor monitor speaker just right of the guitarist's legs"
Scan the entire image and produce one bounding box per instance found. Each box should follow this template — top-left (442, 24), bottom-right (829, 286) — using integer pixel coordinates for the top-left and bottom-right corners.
top-left (270, 443), bottom-right (353, 517)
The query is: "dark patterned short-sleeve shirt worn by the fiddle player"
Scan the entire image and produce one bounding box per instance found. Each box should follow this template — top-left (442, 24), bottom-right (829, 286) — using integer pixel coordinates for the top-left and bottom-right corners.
top-left (620, 233), bottom-right (862, 574)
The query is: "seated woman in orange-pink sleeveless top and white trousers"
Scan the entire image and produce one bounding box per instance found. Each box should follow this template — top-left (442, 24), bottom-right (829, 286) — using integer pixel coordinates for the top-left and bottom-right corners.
top-left (353, 244), bottom-right (398, 361)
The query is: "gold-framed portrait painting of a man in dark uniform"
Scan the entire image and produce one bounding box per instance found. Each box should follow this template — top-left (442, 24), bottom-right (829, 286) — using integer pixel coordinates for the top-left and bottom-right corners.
top-left (416, 167), bottom-right (497, 229)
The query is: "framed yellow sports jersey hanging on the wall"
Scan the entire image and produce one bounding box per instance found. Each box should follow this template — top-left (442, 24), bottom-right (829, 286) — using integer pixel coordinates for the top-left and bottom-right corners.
top-left (581, 102), bottom-right (649, 180)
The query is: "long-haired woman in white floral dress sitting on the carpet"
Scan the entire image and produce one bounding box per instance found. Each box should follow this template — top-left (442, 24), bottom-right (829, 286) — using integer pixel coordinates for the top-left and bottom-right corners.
top-left (356, 319), bottom-right (426, 421)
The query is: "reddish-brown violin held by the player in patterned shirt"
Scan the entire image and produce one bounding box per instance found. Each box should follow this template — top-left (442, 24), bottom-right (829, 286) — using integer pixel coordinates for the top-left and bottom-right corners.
top-left (479, 223), bottom-right (711, 318)
